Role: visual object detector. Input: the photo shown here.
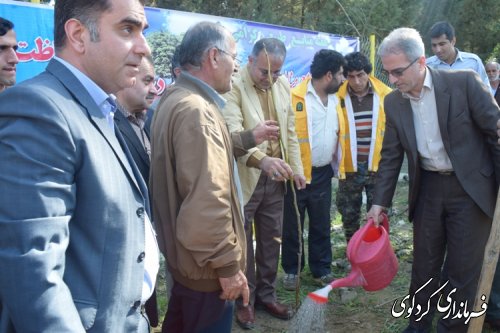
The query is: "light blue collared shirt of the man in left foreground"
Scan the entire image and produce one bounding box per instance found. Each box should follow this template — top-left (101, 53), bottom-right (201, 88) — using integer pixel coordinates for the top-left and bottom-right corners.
top-left (55, 57), bottom-right (160, 303)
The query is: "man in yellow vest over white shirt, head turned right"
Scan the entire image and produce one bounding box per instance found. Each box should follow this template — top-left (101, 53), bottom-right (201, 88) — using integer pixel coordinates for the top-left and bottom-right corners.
top-left (281, 50), bottom-right (345, 290)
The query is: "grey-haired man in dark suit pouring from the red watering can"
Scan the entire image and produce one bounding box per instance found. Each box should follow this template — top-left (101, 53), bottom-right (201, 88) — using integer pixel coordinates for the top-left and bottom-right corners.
top-left (368, 28), bottom-right (500, 332)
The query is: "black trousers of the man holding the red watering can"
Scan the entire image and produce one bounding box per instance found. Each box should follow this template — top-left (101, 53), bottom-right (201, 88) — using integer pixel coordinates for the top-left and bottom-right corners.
top-left (409, 170), bottom-right (491, 333)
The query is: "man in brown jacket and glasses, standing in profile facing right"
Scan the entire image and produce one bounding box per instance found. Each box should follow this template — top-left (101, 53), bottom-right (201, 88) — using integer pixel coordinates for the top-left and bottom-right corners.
top-left (150, 22), bottom-right (249, 332)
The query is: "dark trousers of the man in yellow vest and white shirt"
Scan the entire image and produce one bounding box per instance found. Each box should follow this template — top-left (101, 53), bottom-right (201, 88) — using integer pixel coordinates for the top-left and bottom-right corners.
top-left (281, 165), bottom-right (333, 278)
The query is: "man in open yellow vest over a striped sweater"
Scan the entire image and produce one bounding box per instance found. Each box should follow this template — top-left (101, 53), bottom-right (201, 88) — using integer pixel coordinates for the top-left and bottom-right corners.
top-left (337, 52), bottom-right (391, 242)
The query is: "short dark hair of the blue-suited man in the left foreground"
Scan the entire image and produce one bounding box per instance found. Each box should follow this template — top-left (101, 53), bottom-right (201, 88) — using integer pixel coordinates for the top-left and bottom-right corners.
top-left (54, 0), bottom-right (145, 49)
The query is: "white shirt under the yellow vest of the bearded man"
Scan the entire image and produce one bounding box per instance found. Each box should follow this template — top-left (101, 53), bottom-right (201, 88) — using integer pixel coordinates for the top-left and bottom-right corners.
top-left (306, 80), bottom-right (339, 167)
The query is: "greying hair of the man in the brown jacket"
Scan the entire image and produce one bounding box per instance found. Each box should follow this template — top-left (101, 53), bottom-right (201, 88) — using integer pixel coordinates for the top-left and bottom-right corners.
top-left (179, 22), bottom-right (229, 68)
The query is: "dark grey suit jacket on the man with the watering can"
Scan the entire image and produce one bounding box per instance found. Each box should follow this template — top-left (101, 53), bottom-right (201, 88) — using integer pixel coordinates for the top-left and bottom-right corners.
top-left (373, 69), bottom-right (500, 220)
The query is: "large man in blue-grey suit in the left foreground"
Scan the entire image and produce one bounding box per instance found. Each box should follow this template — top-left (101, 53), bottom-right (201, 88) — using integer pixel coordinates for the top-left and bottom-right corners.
top-left (0, 0), bottom-right (159, 333)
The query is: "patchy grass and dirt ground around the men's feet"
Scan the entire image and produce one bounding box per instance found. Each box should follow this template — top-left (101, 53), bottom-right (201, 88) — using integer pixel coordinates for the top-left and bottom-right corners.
top-left (155, 175), bottom-right (493, 333)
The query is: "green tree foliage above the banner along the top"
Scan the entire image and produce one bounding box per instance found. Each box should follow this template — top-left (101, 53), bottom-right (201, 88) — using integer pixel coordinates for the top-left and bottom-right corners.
top-left (150, 0), bottom-right (500, 59)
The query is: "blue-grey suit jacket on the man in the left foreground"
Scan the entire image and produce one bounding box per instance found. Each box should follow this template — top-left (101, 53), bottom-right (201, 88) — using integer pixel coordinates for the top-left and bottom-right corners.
top-left (0, 60), bottom-right (149, 333)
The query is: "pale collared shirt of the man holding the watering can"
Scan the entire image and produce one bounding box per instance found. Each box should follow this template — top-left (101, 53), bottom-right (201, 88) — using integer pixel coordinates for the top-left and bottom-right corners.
top-left (403, 69), bottom-right (453, 171)
